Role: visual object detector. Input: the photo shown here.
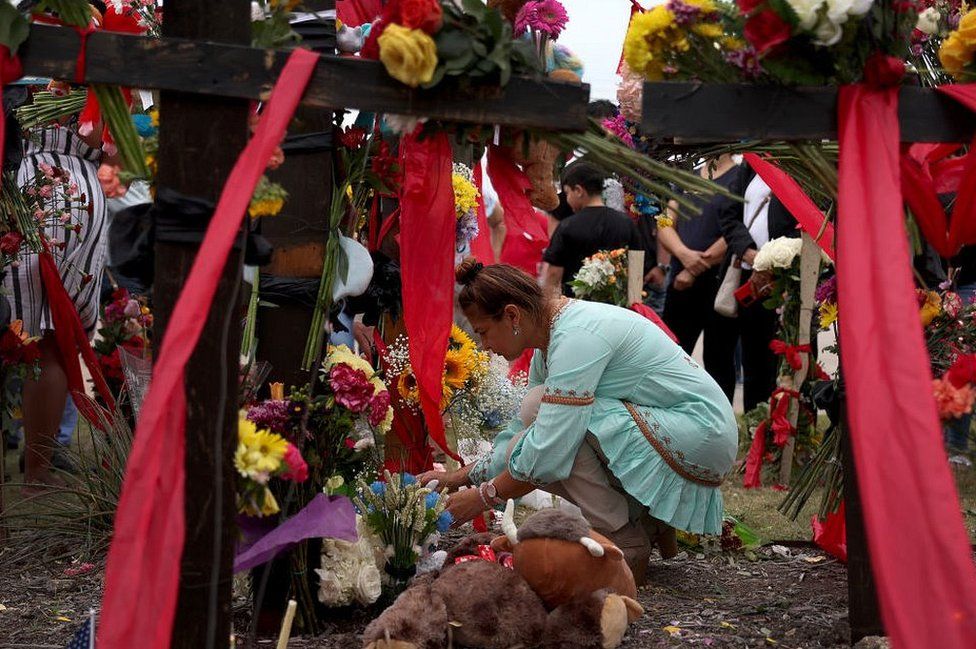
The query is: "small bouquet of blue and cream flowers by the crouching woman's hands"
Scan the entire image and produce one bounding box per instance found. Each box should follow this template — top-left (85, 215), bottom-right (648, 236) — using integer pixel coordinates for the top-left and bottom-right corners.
top-left (353, 471), bottom-right (452, 593)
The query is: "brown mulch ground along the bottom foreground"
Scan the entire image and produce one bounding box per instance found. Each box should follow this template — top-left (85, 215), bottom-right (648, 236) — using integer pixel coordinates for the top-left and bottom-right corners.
top-left (0, 546), bottom-right (848, 649)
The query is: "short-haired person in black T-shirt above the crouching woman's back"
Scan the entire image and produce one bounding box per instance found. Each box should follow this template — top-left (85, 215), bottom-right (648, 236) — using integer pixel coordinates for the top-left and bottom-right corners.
top-left (542, 162), bottom-right (644, 296)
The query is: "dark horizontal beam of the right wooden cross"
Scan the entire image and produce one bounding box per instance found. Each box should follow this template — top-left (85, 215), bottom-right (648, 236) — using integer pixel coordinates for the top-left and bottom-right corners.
top-left (643, 81), bottom-right (976, 142)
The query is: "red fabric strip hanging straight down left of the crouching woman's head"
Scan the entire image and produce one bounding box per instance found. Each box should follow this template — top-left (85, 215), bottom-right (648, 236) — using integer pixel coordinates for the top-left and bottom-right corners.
top-left (400, 132), bottom-right (461, 461)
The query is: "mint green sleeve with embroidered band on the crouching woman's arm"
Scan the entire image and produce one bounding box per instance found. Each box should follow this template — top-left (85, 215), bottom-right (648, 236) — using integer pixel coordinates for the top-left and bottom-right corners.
top-left (508, 328), bottom-right (613, 484)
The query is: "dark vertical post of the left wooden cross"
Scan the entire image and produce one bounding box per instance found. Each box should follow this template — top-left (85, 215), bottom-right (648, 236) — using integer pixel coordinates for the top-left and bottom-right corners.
top-left (154, 5), bottom-right (250, 649)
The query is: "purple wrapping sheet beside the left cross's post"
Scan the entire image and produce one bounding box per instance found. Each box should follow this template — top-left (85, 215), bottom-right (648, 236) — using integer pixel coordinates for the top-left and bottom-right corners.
top-left (234, 494), bottom-right (359, 572)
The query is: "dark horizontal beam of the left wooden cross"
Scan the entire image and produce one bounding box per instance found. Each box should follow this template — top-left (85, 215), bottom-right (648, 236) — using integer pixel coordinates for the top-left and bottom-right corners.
top-left (20, 25), bottom-right (589, 131)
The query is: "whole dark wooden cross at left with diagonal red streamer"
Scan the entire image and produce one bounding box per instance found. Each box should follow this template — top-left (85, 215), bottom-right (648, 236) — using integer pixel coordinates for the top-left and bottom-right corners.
top-left (13, 0), bottom-right (589, 649)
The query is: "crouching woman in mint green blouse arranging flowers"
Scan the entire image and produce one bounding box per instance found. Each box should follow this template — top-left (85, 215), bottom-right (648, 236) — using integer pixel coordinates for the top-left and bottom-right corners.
top-left (421, 259), bottom-right (738, 574)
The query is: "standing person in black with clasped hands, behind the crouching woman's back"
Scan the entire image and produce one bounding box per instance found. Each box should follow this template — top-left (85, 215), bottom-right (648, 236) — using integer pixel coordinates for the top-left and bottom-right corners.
top-left (658, 154), bottom-right (742, 402)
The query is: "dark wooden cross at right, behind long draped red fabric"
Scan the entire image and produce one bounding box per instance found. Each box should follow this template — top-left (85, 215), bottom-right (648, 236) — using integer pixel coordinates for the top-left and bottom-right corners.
top-left (642, 81), bottom-right (976, 643)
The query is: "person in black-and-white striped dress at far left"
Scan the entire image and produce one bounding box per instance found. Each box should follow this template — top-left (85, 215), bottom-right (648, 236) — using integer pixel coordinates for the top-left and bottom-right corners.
top-left (3, 125), bottom-right (107, 492)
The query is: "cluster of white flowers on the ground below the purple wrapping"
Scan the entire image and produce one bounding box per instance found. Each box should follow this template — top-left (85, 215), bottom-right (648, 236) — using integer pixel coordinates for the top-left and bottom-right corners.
top-left (315, 516), bottom-right (385, 606)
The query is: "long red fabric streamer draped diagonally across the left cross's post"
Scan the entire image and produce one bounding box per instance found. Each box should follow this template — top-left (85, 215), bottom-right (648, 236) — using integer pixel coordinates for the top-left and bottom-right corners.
top-left (98, 49), bottom-right (319, 649)
